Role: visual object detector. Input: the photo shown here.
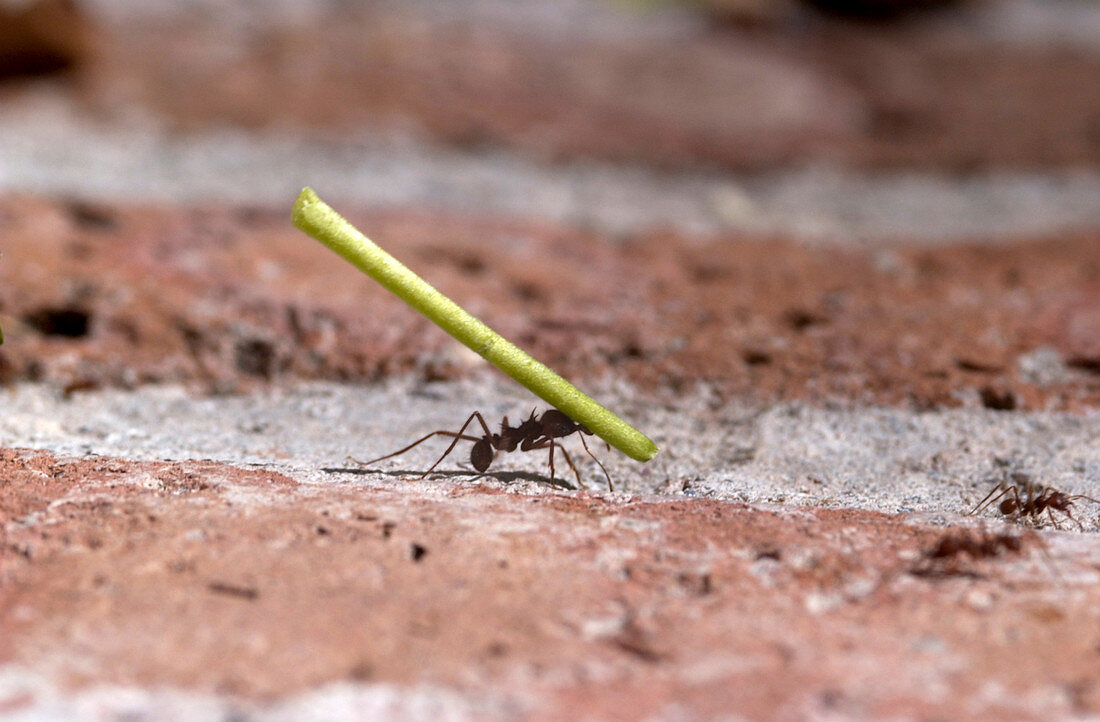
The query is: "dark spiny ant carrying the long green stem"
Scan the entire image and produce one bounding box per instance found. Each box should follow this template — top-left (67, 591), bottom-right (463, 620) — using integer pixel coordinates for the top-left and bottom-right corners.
top-left (352, 408), bottom-right (615, 491)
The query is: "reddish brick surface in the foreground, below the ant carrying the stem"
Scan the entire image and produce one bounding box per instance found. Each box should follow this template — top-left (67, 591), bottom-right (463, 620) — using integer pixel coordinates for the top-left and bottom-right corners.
top-left (0, 450), bottom-right (1100, 719)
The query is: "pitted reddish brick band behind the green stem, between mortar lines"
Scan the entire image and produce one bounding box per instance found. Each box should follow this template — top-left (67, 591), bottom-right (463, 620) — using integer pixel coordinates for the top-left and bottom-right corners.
top-left (0, 196), bottom-right (1100, 409)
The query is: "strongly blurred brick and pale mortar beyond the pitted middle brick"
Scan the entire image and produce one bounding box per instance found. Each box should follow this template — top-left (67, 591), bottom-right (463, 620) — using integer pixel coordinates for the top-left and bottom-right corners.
top-left (0, 0), bottom-right (1100, 244)
